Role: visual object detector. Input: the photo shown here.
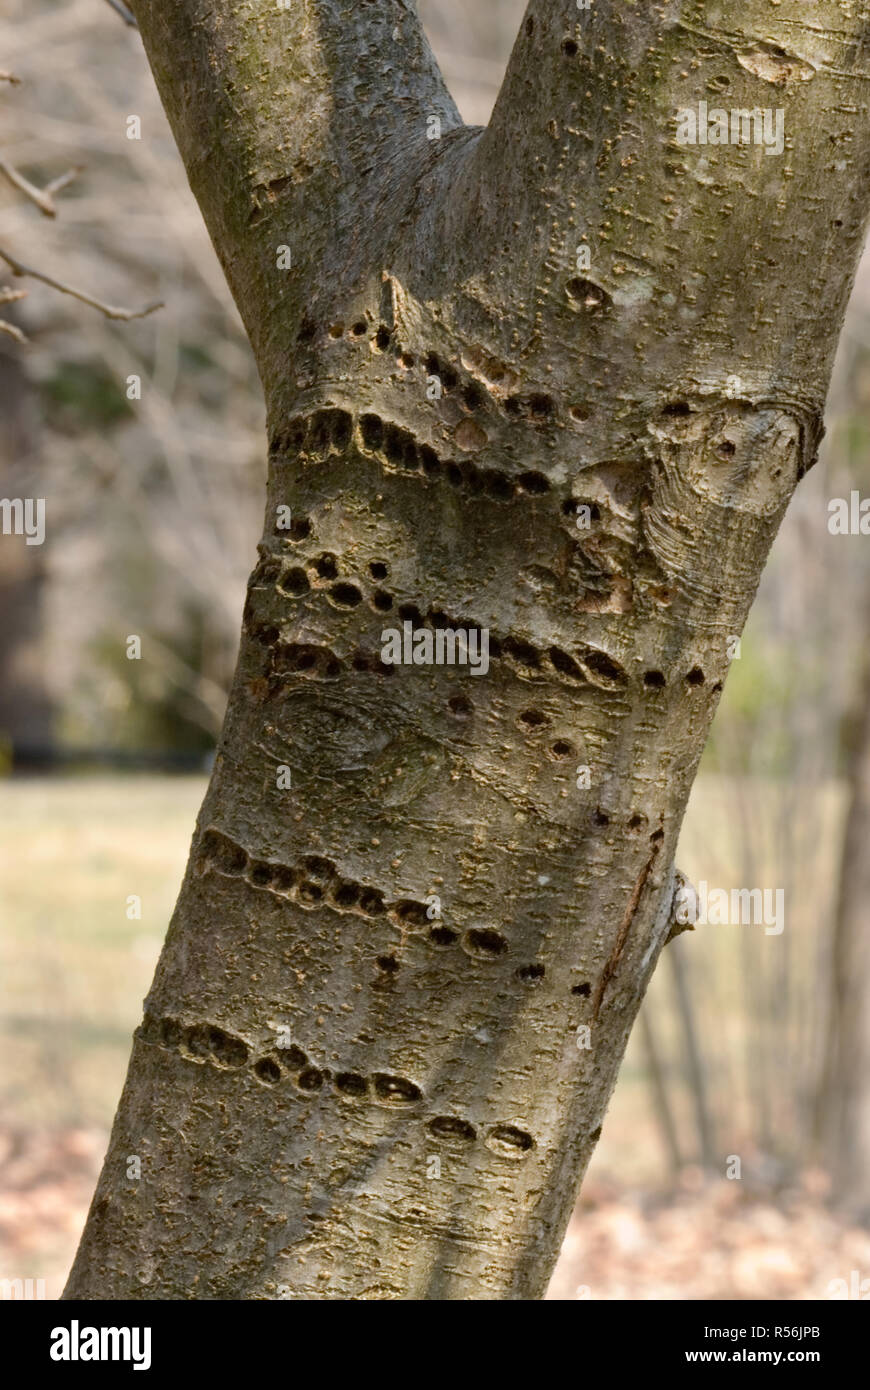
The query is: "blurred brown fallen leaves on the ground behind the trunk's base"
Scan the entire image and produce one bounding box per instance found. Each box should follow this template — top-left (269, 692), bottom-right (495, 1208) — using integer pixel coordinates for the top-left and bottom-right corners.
top-left (0, 1129), bottom-right (870, 1300)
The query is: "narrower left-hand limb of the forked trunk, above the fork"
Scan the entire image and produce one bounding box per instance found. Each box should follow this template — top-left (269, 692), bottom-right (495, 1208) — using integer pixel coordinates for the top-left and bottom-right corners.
top-left (132, 0), bottom-right (461, 370)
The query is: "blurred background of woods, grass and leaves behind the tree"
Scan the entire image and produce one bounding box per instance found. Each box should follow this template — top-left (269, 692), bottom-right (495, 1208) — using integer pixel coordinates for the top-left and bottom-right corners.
top-left (0, 0), bottom-right (870, 1298)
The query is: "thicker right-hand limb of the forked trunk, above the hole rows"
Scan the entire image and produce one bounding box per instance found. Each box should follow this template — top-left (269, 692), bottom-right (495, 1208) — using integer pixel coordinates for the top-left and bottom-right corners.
top-left (443, 0), bottom-right (870, 413)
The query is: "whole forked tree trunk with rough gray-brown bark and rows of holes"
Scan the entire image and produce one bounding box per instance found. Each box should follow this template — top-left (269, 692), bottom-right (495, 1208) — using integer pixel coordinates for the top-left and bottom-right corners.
top-left (67, 0), bottom-right (870, 1298)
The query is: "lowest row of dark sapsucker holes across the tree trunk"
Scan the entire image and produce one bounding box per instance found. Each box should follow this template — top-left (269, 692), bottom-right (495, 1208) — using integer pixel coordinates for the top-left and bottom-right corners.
top-left (139, 1013), bottom-right (535, 1158)
